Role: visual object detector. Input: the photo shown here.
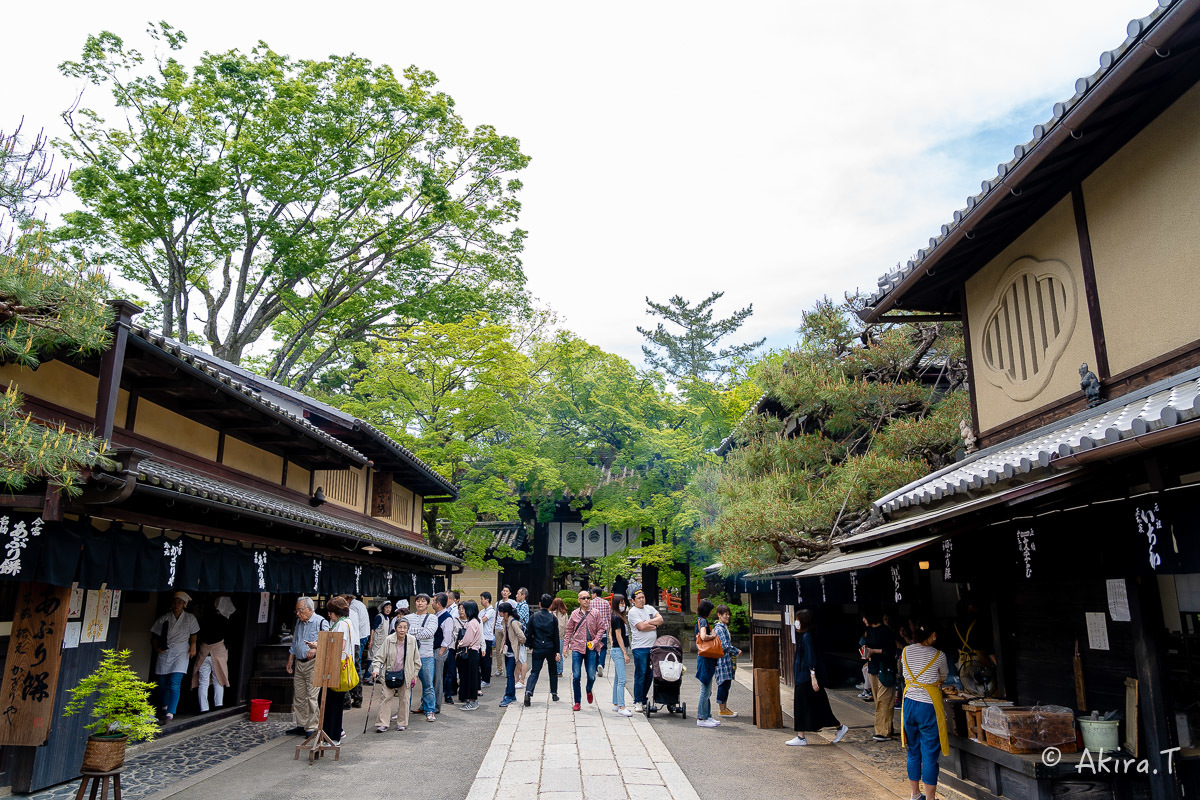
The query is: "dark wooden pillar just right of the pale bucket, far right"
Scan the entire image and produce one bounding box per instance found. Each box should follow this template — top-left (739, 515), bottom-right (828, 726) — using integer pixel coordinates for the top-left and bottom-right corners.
top-left (1126, 578), bottom-right (1181, 800)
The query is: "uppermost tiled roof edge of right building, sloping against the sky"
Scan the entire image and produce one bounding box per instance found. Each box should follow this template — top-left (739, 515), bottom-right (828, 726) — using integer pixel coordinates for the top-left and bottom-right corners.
top-left (868, 0), bottom-right (1184, 306)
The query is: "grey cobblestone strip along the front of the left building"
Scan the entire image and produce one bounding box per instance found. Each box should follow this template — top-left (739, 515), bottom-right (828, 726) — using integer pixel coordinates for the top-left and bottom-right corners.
top-left (24, 720), bottom-right (290, 800)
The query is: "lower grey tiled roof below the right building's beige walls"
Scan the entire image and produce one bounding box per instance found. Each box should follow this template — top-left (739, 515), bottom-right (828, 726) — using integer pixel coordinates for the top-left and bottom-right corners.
top-left (875, 368), bottom-right (1200, 513)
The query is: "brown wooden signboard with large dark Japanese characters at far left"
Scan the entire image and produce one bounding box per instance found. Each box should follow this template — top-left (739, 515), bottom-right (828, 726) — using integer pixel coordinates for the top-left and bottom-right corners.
top-left (0, 583), bottom-right (71, 747)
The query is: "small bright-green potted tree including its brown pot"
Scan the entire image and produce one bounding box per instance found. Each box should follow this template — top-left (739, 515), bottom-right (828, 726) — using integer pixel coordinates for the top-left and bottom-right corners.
top-left (64, 650), bottom-right (158, 772)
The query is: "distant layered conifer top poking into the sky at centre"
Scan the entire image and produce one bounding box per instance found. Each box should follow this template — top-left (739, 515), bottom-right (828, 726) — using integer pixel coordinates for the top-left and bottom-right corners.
top-left (637, 291), bottom-right (766, 385)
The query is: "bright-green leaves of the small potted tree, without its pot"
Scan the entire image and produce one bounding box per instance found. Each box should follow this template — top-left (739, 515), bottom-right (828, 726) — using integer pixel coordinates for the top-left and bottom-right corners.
top-left (62, 650), bottom-right (158, 741)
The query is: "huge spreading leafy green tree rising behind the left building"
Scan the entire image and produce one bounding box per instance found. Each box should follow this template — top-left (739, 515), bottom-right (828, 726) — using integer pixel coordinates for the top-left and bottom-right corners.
top-left (58, 23), bottom-right (529, 387)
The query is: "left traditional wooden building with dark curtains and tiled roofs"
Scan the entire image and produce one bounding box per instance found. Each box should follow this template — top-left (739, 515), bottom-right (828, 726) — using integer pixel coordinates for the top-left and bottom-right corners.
top-left (0, 301), bottom-right (460, 792)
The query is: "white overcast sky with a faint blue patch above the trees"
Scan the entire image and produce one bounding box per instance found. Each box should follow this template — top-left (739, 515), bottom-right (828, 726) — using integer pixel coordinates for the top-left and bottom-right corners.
top-left (0, 0), bottom-right (1153, 362)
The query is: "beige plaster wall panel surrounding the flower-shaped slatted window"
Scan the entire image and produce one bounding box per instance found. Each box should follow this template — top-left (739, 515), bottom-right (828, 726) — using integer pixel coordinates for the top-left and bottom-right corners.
top-left (966, 196), bottom-right (1096, 432)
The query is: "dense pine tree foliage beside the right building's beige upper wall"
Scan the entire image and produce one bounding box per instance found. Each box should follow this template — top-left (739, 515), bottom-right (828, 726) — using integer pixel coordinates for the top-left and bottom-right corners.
top-left (683, 297), bottom-right (970, 571)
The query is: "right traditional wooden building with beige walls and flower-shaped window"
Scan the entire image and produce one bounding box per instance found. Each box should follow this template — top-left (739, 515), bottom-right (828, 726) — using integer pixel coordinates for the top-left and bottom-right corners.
top-left (775, 0), bottom-right (1200, 799)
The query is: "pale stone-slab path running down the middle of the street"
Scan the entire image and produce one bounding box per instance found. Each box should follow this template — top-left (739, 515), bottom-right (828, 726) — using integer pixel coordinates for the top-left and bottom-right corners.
top-left (467, 674), bottom-right (698, 800)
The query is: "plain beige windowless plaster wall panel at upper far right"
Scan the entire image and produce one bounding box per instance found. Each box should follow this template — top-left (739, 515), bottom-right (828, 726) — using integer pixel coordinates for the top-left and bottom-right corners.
top-left (1084, 77), bottom-right (1200, 374)
